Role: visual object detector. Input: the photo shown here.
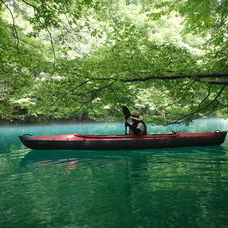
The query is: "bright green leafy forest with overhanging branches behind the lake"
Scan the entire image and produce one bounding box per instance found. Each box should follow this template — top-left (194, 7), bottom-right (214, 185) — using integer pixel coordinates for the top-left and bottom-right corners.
top-left (0, 0), bottom-right (228, 124)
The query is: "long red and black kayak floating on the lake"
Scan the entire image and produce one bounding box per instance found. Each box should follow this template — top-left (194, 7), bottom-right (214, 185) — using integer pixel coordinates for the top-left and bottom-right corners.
top-left (19, 131), bottom-right (227, 150)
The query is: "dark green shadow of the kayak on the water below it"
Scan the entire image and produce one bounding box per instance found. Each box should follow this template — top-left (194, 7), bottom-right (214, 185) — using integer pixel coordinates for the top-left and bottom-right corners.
top-left (20, 146), bottom-right (226, 167)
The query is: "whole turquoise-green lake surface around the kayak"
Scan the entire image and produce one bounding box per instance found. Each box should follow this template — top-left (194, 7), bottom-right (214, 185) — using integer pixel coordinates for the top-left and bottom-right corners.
top-left (0, 119), bottom-right (228, 228)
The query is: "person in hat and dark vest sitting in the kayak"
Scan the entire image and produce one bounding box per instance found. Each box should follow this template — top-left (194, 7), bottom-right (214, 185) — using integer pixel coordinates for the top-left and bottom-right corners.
top-left (125, 111), bottom-right (147, 135)
